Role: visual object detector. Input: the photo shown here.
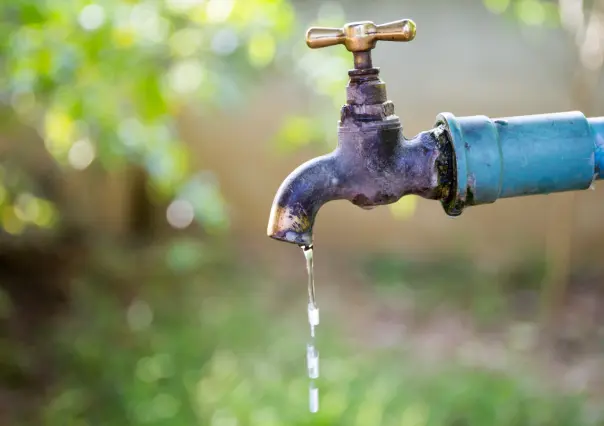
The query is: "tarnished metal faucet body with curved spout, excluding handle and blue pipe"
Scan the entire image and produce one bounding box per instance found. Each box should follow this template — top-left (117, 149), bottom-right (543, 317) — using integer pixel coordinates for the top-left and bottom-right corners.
top-left (268, 69), bottom-right (450, 245)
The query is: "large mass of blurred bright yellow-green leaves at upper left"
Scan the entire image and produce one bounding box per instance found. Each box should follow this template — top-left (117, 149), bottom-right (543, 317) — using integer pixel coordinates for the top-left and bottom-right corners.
top-left (0, 0), bottom-right (295, 232)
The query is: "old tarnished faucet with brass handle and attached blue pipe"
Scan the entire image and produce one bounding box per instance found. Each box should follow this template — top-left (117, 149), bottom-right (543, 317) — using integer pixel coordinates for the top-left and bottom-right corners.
top-left (267, 19), bottom-right (604, 247)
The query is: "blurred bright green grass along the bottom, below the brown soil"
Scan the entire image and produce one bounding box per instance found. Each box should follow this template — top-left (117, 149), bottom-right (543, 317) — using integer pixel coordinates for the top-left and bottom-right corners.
top-left (27, 243), bottom-right (597, 426)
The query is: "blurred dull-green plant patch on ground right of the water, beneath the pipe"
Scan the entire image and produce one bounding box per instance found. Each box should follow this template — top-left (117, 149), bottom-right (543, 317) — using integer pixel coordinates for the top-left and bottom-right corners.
top-left (364, 255), bottom-right (545, 326)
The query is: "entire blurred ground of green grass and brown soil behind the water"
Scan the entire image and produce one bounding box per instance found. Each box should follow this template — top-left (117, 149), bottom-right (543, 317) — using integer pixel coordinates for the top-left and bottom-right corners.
top-left (2, 239), bottom-right (602, 425)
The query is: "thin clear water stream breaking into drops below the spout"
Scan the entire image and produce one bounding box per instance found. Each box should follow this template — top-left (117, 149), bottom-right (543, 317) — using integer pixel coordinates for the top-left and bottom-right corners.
top-left (302, 246), bottom-right (319, 413)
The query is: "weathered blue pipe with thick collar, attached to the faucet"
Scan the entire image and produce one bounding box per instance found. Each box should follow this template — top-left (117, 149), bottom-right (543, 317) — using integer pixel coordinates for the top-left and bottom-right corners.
top-left (437, 112), bottom-right (604, 216)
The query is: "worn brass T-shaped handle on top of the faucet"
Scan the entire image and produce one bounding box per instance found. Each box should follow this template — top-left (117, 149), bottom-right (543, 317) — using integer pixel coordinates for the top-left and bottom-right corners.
top-left (306, 19), bottom-right (416, 53)
